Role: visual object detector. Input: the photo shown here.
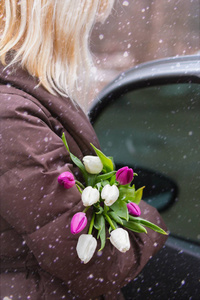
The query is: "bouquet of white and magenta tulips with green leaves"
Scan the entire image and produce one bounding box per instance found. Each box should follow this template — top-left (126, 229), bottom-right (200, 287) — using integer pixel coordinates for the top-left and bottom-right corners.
top-left (58, 134), bottom-right (167, 263)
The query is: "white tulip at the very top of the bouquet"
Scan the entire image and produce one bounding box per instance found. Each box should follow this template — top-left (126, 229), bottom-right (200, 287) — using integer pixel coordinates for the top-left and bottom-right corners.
top-left (83, 155), bottom-right (103, 174)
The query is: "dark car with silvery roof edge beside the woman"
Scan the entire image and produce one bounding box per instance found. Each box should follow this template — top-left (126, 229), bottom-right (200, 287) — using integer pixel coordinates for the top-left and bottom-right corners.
top-left (89, 54), bottom-right (200, 300)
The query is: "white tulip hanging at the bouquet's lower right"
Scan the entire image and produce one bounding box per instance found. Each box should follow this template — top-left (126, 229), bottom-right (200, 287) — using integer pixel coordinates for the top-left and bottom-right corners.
top-left (110, 228), bottom-right (130, 252)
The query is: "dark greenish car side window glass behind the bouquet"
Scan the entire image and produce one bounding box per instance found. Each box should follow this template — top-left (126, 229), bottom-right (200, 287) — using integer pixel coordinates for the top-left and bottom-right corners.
top-left (94, 83), bottom-right (200, 242)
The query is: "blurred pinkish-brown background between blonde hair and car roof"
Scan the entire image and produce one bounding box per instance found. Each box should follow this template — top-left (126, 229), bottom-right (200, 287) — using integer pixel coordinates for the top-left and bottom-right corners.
top-left (90, 0), bottom-right (200, 101)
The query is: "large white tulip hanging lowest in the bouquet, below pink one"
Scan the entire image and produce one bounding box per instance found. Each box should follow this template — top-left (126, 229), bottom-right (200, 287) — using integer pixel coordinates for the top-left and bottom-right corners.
top-left (76, 234), bottom-right (97, 264)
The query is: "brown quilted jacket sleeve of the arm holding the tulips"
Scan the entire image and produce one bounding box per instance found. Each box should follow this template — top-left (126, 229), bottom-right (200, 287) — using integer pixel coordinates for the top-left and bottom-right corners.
top-left (1, 90), bottom-right (166, 299)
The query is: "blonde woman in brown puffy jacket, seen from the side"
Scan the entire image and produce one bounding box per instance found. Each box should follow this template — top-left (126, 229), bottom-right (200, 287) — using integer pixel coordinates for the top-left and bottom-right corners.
top-left (0, 0), bottom-right (166, 300)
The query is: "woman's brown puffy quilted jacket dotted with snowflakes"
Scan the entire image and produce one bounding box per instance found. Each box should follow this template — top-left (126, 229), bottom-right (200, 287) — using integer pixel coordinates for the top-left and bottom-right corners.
top-left (0, 62), bottom-right (166, 300)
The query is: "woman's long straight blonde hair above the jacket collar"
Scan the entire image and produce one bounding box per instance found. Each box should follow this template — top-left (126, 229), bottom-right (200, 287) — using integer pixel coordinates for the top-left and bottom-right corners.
top-left (0, 0), bottom-right (114, 109)
